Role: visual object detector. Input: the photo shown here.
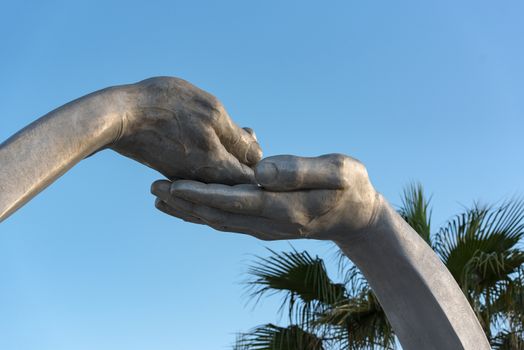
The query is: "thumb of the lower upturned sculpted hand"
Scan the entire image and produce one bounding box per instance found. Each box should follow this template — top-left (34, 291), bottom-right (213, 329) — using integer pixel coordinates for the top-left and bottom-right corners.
top-left (255, 154), bottom-right (365, 191)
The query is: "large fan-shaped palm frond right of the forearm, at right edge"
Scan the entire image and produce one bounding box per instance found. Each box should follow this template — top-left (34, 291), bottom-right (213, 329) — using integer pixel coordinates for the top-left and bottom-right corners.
top-left (435, 200), bottom-right (524, 289)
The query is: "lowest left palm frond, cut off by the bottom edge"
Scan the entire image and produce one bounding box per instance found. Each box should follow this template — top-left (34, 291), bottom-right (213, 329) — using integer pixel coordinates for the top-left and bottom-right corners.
top-left (234, 323), bottom-right (324, 350)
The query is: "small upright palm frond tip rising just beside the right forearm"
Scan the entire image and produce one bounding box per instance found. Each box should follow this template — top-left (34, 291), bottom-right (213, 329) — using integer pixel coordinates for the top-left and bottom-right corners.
top-left (398, 183), bottom-right (432, 246)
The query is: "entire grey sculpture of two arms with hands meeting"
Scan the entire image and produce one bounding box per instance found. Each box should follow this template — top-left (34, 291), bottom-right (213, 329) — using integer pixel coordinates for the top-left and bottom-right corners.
top-left (0, 77), bottom-right (490, 350)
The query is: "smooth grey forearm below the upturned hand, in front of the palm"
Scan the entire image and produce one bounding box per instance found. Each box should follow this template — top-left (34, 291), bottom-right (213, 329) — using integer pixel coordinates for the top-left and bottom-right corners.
top-left (336, 198), bottom-right (490, 350)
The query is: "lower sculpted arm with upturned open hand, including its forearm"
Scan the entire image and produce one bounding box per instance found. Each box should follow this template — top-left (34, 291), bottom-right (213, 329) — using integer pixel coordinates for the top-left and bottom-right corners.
top-left (152, 155), bottom-right (490, 350)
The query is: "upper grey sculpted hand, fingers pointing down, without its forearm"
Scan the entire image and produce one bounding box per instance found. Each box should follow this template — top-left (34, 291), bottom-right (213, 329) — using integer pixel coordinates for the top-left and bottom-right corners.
top-left (111, 77), bottom-right (262, 184)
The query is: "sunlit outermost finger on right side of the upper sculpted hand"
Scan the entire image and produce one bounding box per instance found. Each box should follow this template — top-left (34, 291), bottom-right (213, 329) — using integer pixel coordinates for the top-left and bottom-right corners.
top-left (214, 106), bottom-right (262, 166)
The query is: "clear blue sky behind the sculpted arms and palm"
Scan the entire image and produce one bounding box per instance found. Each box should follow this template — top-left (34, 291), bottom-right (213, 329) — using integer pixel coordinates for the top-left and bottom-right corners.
top-left (0, 0), bottom-right (524, 350)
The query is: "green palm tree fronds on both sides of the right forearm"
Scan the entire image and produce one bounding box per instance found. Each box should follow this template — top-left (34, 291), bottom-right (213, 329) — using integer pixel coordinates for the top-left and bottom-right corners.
top-left (235, 184), bottom-right (524, 350)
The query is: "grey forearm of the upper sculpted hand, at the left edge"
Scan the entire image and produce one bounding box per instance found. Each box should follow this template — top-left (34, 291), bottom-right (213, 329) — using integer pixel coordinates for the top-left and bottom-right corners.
top-left (0, 88), bottom-right (129, 221)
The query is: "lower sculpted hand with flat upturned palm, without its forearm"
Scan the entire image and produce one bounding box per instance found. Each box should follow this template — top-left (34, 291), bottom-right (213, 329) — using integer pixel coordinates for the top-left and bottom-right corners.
top-left (152, 154), bottom-right (379, 240)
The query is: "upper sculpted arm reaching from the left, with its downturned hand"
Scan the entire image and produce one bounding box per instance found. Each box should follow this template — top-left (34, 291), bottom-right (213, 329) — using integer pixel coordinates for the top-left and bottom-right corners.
top-left (0, 77), bottom-right (261, 221)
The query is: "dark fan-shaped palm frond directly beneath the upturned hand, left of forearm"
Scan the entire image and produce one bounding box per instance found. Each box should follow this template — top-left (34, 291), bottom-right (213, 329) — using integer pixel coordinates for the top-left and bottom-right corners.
top-left (247, 250), bottom-right (346, 324)
